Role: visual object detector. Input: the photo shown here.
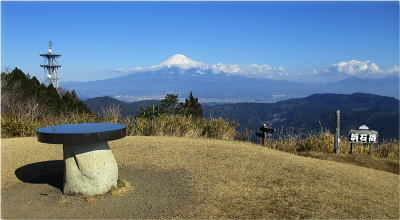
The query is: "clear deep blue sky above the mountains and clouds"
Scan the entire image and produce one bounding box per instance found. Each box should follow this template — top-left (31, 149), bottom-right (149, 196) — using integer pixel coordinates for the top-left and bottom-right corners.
top-left (1, 2), bottom-right (399, 81)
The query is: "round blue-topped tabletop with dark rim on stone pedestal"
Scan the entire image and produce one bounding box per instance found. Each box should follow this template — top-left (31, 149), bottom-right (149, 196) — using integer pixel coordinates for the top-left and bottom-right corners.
top-left (36, 123), bottom-right (126, 144)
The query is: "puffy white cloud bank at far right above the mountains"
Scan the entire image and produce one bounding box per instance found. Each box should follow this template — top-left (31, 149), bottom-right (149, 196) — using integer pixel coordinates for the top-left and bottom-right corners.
top-left (313, 60), bottom-right (400, 77)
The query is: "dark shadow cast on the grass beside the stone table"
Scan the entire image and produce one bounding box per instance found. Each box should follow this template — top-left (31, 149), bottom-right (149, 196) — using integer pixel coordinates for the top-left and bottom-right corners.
top-left (15, 160), bottom-right (64, 191)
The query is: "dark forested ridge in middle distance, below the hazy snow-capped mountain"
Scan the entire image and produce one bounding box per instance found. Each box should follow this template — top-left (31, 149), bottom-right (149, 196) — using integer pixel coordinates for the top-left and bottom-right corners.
top-left (86, 93), bottom-right (400, 139)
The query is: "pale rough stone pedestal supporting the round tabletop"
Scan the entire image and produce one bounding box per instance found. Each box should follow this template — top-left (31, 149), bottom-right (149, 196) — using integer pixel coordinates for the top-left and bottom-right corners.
top-left (63, 142), bottom-right (118, 195)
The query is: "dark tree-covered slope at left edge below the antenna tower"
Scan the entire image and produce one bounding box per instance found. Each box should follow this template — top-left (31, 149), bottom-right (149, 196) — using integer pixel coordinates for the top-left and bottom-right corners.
top-left (1, 68), bottom-right (90, 114)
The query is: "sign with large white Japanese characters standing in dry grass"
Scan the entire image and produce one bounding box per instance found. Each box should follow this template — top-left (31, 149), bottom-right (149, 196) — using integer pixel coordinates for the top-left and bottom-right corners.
top-left (349, 125), bottom-right (379, 153)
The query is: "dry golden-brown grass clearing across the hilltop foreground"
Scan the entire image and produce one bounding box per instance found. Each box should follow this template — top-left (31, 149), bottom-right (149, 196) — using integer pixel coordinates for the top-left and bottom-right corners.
top-left (1, 136), bottom-right (400, 219)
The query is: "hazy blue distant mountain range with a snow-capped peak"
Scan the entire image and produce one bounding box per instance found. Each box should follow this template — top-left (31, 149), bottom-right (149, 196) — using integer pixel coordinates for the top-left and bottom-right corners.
top-left (62, 55), bottom-right (399, 103)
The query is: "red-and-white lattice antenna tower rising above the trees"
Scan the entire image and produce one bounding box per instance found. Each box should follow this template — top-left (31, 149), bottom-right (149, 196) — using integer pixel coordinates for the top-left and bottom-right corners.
top-left (40, 41), bottom-right (61, 91)
